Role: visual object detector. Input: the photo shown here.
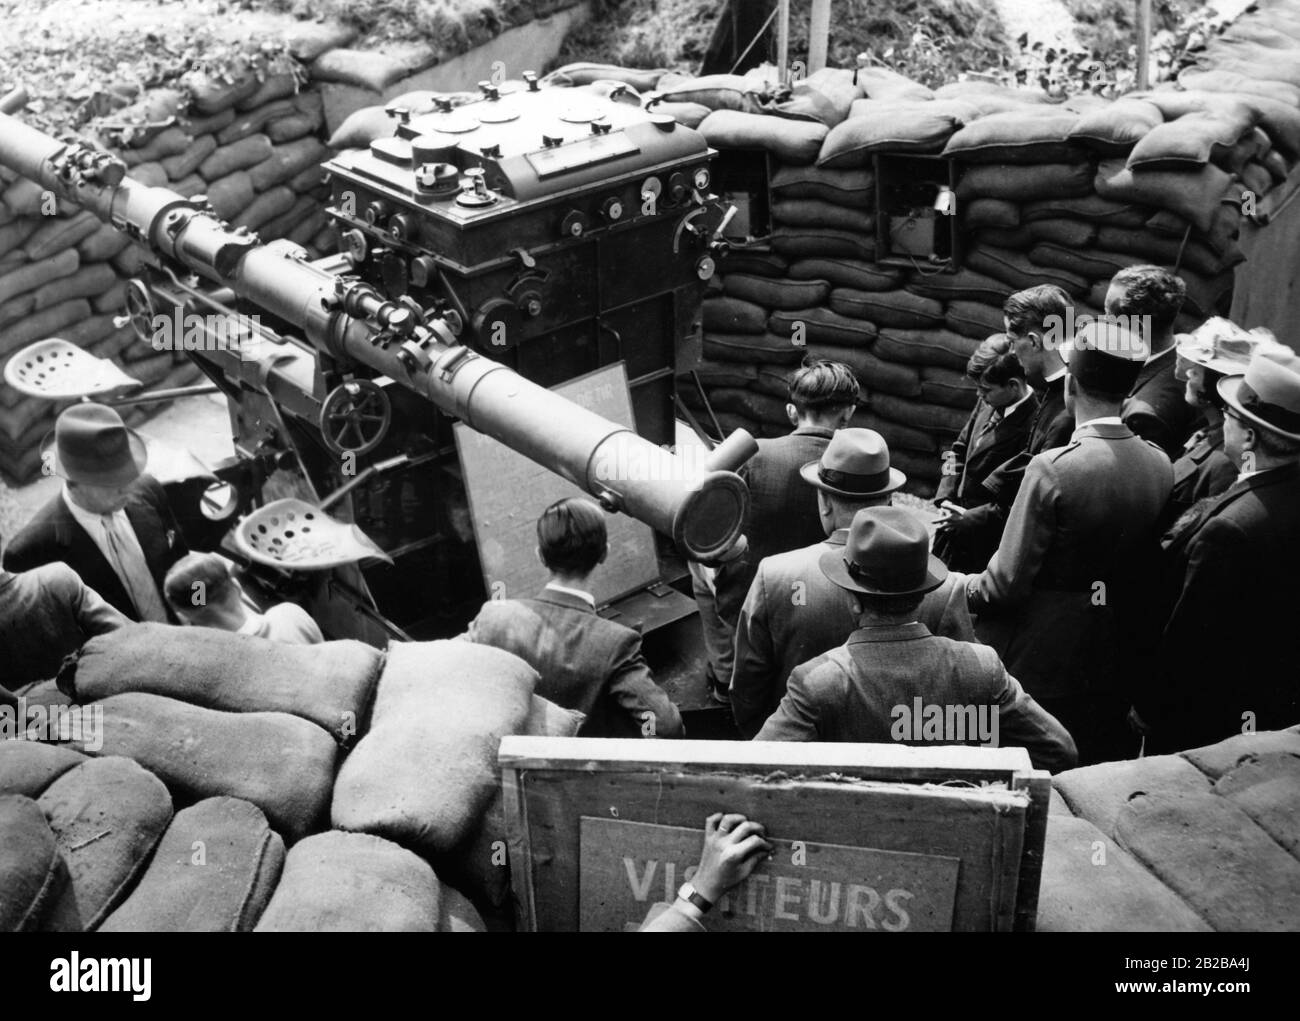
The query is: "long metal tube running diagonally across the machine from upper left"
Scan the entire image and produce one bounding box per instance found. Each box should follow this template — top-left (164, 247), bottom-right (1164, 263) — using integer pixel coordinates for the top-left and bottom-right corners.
top-left (0, 113), bottom-right (749, 561)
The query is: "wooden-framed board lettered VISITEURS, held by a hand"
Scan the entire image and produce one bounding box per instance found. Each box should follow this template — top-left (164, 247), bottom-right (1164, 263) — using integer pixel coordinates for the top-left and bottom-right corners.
top-left (501, 737), bottom-right (1049, 933)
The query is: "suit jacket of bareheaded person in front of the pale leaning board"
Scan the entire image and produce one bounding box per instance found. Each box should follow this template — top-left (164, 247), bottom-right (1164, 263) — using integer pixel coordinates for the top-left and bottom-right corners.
top-left (465, 588), bottom-right (683, 737)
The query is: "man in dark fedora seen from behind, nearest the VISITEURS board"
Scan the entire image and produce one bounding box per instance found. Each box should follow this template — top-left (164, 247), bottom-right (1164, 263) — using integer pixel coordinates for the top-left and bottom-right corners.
top-left (758, 507), bottom-right (1076, 771)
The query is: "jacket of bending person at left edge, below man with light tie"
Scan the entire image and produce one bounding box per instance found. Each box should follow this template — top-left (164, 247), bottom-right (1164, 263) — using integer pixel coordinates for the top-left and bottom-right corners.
top-left (0, 563), bottom-right (129, 688)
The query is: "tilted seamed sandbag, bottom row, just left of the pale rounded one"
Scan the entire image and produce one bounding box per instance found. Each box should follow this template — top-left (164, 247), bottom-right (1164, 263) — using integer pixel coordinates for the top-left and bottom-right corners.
top-left (99, 797), bottom-right (285, 933)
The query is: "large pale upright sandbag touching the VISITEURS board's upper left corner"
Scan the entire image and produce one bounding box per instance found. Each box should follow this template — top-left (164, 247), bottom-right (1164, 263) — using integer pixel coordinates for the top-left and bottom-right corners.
top-left (330, 641), bottom-right (537, 855)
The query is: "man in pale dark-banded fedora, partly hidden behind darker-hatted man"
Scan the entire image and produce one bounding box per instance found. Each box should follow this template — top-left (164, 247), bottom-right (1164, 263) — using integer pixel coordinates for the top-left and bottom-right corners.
top-left (731, 429), bottom-right (975, 737)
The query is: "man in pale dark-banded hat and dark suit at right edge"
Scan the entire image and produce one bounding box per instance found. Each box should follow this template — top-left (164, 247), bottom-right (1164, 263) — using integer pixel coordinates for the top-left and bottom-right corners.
top-left (1135, 345), bottom-right (1300, 750)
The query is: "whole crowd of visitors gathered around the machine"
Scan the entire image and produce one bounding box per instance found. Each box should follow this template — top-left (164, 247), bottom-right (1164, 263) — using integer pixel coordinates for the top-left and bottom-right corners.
top-left (0, 267), bottom-right (1300, 770)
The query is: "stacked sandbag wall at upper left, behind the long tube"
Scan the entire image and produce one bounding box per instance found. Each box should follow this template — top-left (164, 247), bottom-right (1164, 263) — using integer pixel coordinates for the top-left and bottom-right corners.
top-left (0, 73), bottom-right (334, 483)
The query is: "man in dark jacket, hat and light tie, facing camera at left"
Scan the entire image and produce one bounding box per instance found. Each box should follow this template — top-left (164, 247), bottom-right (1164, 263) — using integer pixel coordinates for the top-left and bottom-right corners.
top-left (4, 403), bottom-right (187, 622)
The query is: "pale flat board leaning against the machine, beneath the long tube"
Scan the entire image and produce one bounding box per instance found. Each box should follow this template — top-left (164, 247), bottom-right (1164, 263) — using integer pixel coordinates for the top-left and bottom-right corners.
top-left (455, 362), bottom-right (659, 606)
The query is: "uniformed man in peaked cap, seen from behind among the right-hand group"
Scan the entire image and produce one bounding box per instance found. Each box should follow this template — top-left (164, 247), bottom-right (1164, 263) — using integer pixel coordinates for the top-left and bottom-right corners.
top-left (967, 320), bottom-right (1173, 765)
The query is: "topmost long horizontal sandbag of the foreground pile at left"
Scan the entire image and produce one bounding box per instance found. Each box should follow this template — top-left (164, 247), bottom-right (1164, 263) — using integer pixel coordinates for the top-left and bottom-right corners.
top-left (59, 624), bottom-right (384, 744)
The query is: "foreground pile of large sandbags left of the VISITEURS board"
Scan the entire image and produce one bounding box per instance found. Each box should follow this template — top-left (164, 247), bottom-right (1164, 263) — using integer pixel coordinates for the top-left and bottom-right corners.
top-left (0, 624), bottom-right (584, 931)
